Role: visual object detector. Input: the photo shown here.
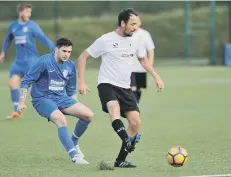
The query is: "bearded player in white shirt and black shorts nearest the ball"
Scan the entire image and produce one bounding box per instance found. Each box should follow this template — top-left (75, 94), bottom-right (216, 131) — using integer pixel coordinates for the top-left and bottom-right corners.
top-left (78, 8), bottom-right (164, 168)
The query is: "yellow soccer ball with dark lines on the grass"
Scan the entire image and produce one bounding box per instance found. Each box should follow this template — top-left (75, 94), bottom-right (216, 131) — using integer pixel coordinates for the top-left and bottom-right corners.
top-left (167, 146), bottom-right (188, 167)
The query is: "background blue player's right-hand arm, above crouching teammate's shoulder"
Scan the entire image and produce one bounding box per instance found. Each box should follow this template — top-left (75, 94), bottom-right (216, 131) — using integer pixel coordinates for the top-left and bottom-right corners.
top-left (33, 23), bottom-right (55, 52)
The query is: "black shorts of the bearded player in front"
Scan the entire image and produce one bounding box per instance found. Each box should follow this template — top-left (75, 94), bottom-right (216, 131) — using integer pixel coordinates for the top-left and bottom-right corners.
top-left (98, 83), bottom-right (140, 118)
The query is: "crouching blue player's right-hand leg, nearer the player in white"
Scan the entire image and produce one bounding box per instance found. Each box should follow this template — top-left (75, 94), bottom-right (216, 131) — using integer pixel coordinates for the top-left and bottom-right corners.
top-left (62, 102), bottom-right (94, 158)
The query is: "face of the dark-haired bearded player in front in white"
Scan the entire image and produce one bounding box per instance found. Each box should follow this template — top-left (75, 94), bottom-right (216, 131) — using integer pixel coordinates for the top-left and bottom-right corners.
top-left (122, 14), bottom-right (139, 36)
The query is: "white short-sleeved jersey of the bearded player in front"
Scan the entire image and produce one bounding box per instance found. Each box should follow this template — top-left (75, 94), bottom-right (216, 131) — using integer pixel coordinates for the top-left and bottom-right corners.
top-left (87, 31), bottom-right (146, 88)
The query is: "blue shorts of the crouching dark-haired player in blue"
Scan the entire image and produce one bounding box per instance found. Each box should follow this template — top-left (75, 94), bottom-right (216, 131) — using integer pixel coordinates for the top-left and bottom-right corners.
top-left (32, 96), bottom-right (77, 120)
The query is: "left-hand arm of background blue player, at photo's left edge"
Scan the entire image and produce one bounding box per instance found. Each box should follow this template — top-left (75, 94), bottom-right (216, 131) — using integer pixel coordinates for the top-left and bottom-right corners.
top-left (0, 25), bottom-right (14, 62)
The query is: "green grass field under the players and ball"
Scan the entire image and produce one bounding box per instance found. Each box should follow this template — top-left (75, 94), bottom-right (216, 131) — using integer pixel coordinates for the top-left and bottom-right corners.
top-left (0, 67), bottom-right (231, 177)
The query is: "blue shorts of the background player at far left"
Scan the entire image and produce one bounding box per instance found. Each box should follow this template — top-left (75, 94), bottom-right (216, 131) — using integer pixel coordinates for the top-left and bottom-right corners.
top-left (9, 58), bottom-right (37, 78)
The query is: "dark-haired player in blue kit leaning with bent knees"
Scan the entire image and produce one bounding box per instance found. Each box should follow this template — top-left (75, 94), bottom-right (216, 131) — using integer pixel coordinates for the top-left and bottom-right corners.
top-left (18, 37), bottom-right (93, 164)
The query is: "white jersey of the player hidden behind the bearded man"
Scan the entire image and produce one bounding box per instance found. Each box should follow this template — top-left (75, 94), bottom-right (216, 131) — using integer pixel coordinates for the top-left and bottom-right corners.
top-left (133, 28), bottom-right (155, 73)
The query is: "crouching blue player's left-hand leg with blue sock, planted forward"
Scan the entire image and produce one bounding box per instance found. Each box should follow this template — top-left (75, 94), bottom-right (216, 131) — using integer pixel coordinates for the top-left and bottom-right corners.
top-left (50, 110), bottom-right (88, 164)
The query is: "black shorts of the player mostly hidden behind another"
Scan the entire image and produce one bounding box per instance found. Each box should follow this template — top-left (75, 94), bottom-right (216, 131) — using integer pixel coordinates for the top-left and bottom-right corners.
top-left (131, 72), bottom-right (147, 89)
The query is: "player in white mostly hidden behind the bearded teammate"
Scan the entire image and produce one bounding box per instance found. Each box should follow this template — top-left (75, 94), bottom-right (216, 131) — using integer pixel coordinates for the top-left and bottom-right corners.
top-left (131, 17), bottom-right (155, 103)
